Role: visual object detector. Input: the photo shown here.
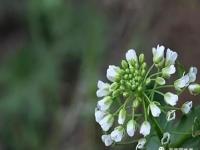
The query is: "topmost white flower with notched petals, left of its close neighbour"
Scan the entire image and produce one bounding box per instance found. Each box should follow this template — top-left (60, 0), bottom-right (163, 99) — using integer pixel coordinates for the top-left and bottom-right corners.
top-left (152, 45), bottom-right (165, 64)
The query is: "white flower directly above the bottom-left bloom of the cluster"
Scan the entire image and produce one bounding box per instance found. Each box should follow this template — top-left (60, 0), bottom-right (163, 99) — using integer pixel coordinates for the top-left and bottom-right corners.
top-left (99, 114), bottom-right (114, 131)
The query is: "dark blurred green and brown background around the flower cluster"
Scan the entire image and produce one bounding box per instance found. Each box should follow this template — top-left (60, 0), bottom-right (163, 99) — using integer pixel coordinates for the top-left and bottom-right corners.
top-left (0, 0), bottom-right (200, 150)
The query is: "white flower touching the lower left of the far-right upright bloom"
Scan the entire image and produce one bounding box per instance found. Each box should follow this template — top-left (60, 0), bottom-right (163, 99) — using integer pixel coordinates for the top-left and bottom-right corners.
top-left (174, 75), bottom-right (190, 91)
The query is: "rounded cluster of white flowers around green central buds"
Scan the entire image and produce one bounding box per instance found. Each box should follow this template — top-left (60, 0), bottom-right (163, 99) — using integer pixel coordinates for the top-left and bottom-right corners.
top-left (95, 45), bottom-right (200, 149)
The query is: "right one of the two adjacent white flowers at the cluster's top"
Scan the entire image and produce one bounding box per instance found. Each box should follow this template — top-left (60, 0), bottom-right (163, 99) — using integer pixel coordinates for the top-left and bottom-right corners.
top-left (165, 48), bottom-right (178, 66)
